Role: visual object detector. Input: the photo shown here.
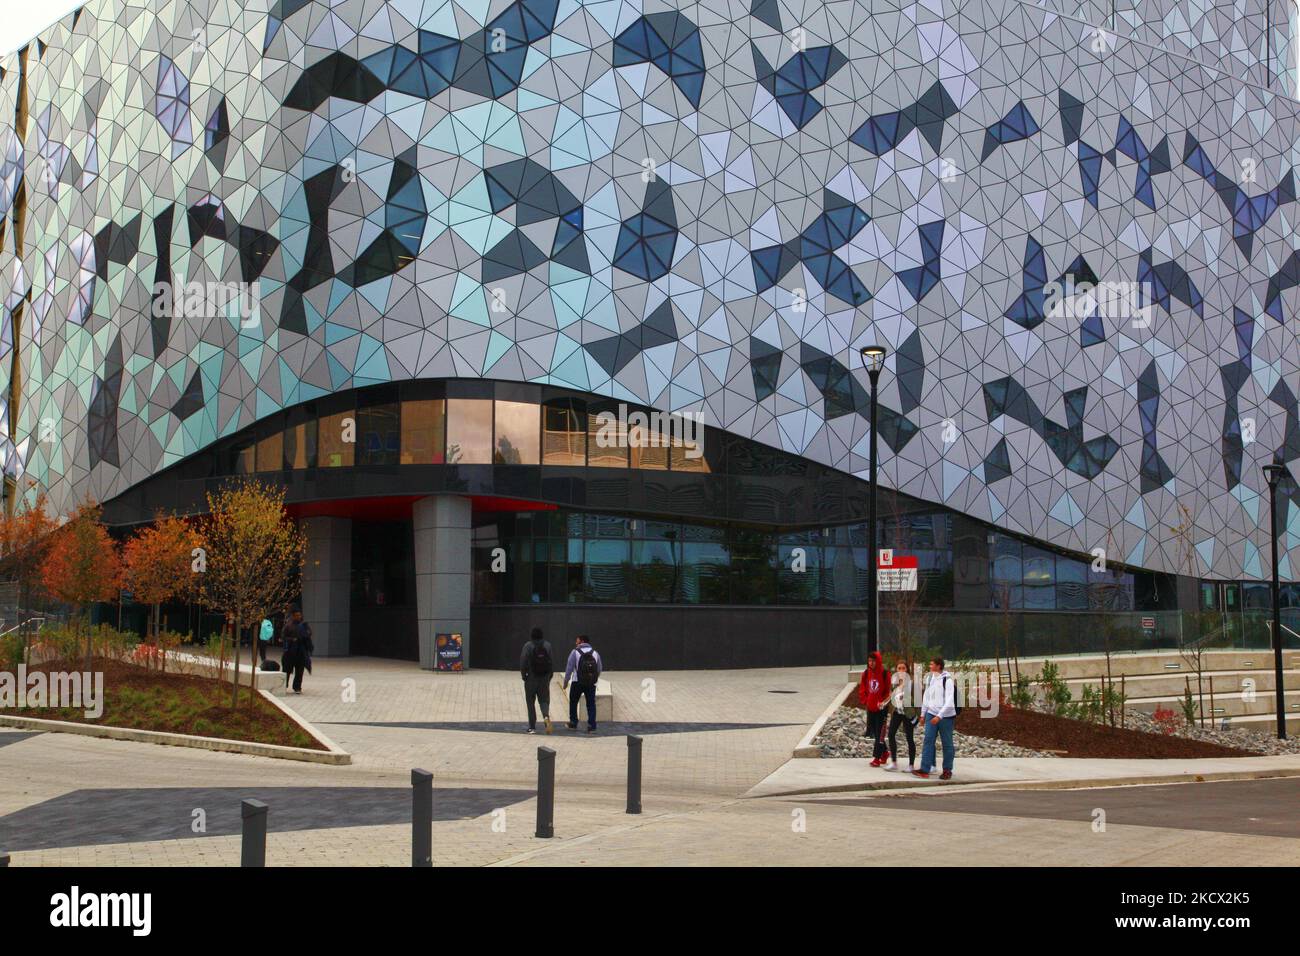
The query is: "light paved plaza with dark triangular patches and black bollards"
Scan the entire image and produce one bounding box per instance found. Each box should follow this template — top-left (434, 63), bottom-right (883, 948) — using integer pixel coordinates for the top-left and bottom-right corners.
top-left (0, 658), bottom-right (1300, 866)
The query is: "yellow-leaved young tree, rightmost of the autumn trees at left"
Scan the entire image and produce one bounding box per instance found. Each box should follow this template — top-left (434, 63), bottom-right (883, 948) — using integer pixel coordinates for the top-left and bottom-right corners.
top-left (195, 481), bottom-right (307, 708)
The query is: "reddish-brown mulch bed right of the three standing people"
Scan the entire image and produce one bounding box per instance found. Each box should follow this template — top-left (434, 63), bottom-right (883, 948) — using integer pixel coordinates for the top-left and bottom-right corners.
top-left (844, 688), bottom-right (1260, 760)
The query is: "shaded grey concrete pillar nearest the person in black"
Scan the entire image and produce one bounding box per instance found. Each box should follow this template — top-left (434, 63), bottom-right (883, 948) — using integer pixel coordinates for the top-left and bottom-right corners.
top-left (303, 518), bottom-right (352, 657)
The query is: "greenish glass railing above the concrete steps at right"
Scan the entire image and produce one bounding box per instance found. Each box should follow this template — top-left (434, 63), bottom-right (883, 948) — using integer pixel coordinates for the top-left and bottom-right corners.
top-left (849, 607), bottom-right (1300, 667)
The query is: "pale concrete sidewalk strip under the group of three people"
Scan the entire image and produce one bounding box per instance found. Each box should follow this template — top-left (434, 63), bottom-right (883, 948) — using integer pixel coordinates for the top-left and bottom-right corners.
top-left (745, 754), bottom-right (1300, 797)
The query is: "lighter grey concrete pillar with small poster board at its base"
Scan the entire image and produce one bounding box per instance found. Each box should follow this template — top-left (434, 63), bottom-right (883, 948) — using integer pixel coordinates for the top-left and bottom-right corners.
top-left (412, 494), bottom-right (473, 670)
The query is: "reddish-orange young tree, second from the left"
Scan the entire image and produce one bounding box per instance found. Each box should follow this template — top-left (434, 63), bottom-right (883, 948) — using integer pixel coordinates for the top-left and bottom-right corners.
top-left (40, 499), bottom-right (122, 670)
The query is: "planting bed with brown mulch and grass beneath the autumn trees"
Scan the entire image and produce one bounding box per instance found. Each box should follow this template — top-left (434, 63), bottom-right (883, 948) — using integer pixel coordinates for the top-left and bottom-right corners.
top-left (0, 658), bottom-right (328, 750)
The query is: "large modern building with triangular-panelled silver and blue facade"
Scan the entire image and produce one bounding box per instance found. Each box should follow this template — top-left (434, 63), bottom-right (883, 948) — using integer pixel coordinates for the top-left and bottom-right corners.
top-left (0, 0), bottom-right (1300, 667)
